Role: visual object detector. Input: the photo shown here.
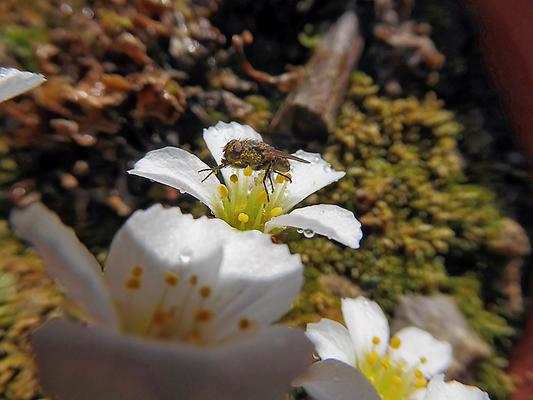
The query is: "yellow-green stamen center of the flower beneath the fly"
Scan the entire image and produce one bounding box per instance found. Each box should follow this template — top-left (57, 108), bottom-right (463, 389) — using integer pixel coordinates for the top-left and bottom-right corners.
top-left (211, 167), bottom-right (291, 231)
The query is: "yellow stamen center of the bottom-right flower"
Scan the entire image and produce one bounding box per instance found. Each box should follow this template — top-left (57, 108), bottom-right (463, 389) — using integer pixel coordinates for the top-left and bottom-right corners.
top-left (357, 337), bottom-right (427, 400)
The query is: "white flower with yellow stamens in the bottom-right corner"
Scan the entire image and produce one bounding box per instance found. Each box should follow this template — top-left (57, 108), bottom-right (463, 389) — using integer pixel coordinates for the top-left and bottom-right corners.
top-left (307, 297), bottom-right (452, 400)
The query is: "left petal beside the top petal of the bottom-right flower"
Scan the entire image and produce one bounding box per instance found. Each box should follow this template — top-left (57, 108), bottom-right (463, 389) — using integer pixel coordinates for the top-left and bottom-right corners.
top-left (306, 318), bottom-right (355, 367)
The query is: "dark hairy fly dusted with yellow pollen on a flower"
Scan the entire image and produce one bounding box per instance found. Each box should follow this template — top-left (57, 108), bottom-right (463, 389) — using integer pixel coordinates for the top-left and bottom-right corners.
top-left (198, 139), bottom-right (309, 200)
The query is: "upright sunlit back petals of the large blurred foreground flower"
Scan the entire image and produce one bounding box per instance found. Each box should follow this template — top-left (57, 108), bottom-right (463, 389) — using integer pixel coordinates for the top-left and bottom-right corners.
top-left (105, 206), bottom-right (303, 342)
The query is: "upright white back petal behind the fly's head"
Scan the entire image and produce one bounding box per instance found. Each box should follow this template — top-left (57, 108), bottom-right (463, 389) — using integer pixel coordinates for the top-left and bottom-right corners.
top-left (204, 121), bottom-right (263, 182)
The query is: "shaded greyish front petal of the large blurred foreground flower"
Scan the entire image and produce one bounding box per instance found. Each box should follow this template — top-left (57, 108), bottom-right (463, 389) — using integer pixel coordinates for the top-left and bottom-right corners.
top-left (32, 319), bottom-right (313, 400)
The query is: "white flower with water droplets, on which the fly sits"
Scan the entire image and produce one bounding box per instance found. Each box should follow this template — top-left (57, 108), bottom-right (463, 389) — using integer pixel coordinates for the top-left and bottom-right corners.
top-left (128, 122), bottom-right (362, 248)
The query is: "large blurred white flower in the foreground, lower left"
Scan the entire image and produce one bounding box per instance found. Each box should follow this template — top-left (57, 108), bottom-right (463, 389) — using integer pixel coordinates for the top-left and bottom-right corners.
top-left (11, 204), bottom-right (312, 400)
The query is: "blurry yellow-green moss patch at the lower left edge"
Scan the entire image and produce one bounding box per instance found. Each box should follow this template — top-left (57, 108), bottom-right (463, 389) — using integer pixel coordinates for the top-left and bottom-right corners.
top-left (0, 220), bottom-right (63, 400)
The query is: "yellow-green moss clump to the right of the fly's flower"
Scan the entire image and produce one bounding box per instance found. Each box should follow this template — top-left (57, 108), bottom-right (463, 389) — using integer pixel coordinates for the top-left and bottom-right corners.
top-left (290, 72), bottom-right (515, 399)
